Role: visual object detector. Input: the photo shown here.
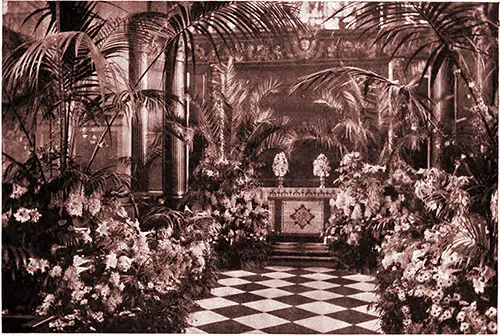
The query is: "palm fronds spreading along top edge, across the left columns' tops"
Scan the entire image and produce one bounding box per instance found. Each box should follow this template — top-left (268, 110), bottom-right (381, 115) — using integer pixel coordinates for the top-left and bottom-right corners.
top-left (128, 1), bottom-right (305, 82)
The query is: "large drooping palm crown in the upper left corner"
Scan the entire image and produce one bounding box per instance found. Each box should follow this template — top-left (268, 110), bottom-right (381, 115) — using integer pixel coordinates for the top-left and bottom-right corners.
top-left (3, 1), bottom-right (136, 179)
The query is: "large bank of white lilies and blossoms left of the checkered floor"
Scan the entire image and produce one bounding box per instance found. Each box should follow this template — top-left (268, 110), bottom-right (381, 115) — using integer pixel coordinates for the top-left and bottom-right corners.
top-left (25, 198), bottom-right (217, 332)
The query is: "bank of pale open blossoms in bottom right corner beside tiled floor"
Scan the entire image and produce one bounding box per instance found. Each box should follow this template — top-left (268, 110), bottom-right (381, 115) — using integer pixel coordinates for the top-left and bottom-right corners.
top-left (378, 218), bottom-right (498, 334)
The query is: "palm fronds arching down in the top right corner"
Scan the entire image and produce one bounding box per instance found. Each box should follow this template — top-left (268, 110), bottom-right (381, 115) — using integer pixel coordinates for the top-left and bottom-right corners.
top-left (338, 2), bottom-right (498, 151)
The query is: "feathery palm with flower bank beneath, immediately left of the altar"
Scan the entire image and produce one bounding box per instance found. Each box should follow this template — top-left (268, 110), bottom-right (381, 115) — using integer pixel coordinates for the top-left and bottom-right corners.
top-left (188, 59), bottom-right (294, 267)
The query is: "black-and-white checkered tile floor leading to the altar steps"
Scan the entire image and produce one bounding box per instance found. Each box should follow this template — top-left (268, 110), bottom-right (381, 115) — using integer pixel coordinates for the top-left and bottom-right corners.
top-left (186, 266), bottom-right (380, 334)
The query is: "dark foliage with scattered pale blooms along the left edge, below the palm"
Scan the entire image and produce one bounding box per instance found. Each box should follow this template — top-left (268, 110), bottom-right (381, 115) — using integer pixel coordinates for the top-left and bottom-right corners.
top-left (2, 153), bottom-right (94, 313)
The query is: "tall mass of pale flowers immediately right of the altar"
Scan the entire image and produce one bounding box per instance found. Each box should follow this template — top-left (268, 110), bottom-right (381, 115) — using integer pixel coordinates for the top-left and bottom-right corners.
top-left (323, 152), bottom-right (386, 269)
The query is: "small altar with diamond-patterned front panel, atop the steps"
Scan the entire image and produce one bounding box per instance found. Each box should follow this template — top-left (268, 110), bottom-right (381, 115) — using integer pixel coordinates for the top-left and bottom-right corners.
top-left (262, 188), bottom-right (335, 236)
